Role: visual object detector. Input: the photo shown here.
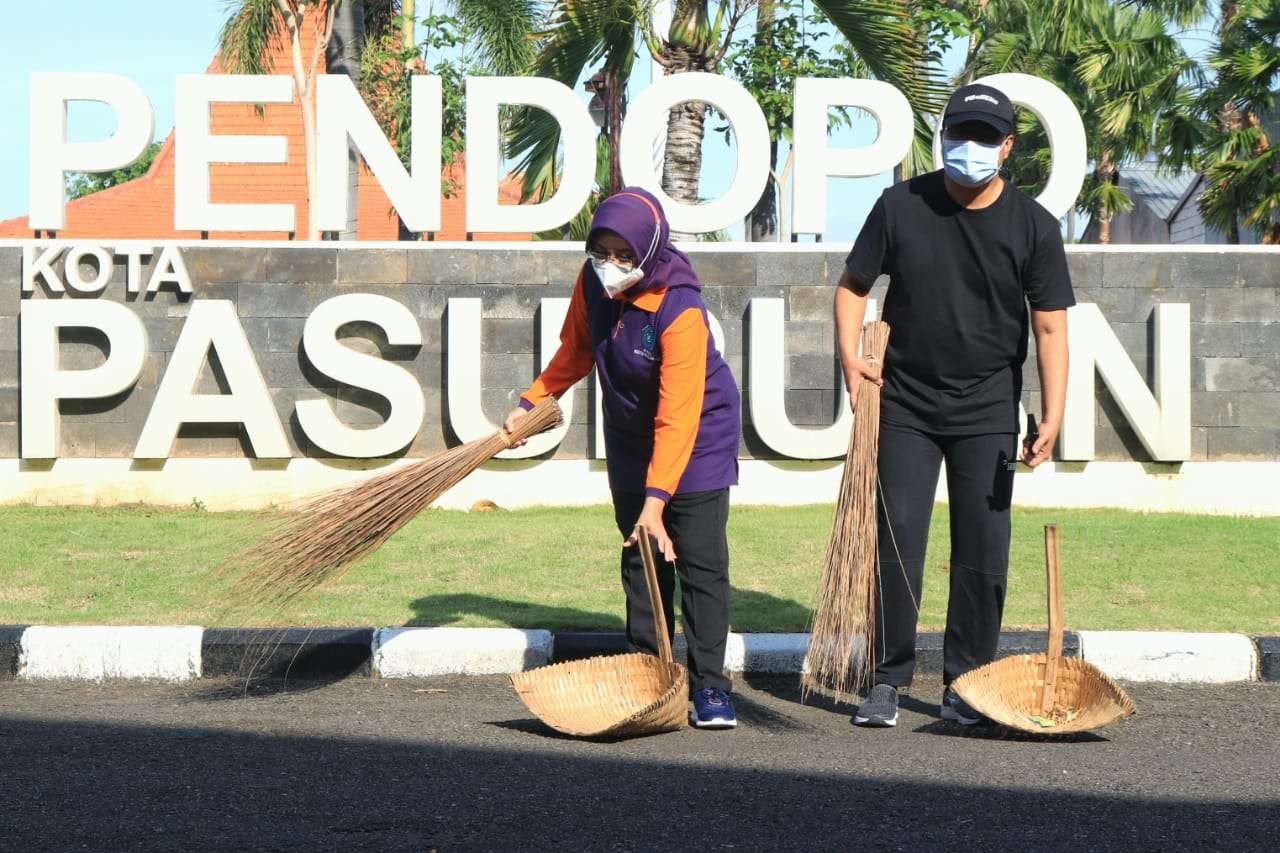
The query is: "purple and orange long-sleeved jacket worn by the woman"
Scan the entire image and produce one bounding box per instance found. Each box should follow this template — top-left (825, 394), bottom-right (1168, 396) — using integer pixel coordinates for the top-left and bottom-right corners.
top-left (521, 263), bottom-right (741, 501)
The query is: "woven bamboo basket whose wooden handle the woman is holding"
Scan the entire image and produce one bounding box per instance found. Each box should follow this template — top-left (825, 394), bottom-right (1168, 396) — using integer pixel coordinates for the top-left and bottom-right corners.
top-left (511, 528), bottom-right (689, 738)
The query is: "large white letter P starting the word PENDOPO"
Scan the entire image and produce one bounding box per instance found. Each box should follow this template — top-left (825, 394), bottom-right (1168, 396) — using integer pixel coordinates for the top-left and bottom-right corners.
top-left (27, 72), bottom-right (155, 231)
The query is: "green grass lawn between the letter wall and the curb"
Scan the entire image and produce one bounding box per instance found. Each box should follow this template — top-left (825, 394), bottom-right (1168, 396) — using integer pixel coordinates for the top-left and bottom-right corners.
top-left (0, 506), bottom-right (1280, 633)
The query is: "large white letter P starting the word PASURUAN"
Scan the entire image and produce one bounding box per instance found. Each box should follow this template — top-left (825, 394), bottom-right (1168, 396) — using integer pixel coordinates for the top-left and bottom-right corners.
top-left (18, 300), bottom-right (147, 459)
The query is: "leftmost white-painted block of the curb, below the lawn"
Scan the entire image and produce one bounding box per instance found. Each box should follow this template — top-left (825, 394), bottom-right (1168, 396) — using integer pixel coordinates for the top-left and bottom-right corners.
top-left (18, 625), bottom-right (205, 681)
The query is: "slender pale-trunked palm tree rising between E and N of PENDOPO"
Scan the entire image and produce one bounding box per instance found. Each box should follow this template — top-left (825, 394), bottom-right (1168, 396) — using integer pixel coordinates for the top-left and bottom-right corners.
top-left (219, 0), bottom-right (342, 240)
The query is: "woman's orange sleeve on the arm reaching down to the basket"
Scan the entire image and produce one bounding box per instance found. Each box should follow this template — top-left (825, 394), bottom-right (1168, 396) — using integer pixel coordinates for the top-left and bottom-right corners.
top-left (645, 307), bottom-right (709, 501)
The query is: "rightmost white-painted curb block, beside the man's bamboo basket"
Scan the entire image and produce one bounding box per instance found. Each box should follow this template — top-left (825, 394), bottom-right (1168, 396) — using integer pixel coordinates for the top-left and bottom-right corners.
top-left (1079, 631), bottom-right (1258, 684)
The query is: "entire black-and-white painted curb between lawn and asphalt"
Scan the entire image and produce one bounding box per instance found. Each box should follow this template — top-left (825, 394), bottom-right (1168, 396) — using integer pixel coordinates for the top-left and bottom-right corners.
top-left (0, 625), bottom-right (1280, 684)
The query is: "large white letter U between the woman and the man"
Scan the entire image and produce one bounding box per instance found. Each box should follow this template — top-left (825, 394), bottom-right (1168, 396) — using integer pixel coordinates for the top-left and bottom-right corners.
top-left (746, 297), bottom-right (876, 459)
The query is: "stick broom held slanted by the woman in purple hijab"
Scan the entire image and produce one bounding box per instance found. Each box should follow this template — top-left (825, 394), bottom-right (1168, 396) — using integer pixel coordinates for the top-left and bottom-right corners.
top-left (219, 397), bottom-right (562, 605)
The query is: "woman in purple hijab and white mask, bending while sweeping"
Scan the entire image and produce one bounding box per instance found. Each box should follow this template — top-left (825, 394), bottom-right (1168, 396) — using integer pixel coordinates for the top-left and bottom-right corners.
top-left (507, 187), bottom-right (740, 729)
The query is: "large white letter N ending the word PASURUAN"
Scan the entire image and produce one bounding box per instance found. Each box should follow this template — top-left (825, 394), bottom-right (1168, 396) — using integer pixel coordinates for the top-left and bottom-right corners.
top-left (1060, 304), bottom-right (1192, 462)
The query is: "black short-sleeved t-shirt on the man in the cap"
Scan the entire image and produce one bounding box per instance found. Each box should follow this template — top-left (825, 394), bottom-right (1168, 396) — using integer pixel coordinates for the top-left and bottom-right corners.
top-left (845, 172), bottom-right (1075, 435)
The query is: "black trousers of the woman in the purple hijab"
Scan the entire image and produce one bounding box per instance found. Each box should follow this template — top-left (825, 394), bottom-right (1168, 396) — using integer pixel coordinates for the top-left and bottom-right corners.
top-left (613, 489), bottom-right (732, 692)
